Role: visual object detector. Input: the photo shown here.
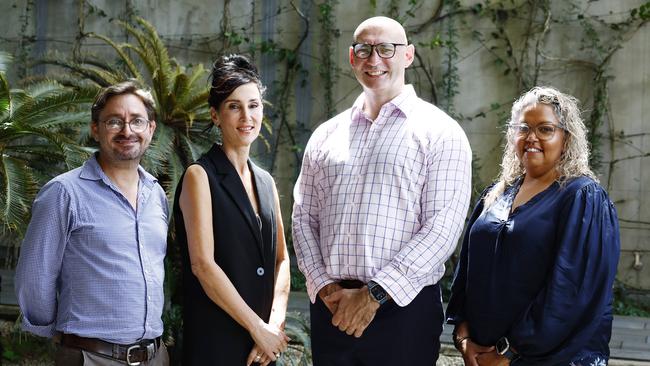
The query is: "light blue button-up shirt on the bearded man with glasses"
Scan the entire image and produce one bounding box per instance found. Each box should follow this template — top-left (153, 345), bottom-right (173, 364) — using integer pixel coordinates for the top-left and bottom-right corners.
top-left (15, 156), bottom-right (168, 344)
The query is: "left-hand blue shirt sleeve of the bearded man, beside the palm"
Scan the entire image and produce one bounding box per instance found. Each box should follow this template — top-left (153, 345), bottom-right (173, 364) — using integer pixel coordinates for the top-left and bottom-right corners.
top-left (15, 182), bottom-right (73, 337)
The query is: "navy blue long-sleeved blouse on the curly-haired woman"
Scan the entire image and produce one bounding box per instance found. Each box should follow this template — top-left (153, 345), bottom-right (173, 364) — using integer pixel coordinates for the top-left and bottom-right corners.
top-left (447, 177), bottom-right (620, 366)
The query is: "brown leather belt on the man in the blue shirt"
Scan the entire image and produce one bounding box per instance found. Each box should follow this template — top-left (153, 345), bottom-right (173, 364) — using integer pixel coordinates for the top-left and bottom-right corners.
top-left (61, 334), bottom-right (161, 365)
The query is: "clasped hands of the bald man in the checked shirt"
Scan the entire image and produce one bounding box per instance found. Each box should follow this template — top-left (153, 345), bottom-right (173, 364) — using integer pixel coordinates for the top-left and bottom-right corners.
top-left (325, 286), bottom-right (379, 338)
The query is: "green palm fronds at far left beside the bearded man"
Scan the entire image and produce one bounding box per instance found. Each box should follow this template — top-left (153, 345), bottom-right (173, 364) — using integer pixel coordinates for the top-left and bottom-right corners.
top-left (0, 53), bottom-right (94, 266)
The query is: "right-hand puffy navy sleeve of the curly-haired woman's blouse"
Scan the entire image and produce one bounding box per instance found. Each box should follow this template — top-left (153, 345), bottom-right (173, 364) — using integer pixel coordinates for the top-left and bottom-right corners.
top-left (506, 182), bottom-right (620, 365)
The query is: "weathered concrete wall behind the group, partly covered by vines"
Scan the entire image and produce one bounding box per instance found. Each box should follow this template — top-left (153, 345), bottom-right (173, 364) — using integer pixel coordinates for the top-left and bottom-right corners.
top-left (0, 0), bottom-right (650, 289)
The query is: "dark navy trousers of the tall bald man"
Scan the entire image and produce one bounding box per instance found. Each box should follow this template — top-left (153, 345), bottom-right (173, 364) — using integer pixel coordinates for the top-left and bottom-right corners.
top-left (310, 285), bottom-right (444, 366)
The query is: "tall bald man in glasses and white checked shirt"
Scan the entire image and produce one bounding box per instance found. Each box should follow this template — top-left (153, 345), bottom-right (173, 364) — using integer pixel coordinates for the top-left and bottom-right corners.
top-left (293, 17), bottom-right (471, 366)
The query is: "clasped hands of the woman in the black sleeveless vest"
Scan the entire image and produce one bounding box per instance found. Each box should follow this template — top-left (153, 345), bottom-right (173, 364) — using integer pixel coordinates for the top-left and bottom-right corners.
top-left (246, 321), bottom-right (289, 365)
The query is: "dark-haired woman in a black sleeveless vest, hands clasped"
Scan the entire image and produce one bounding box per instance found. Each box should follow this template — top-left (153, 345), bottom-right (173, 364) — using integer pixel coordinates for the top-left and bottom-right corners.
top-left (174, 55), bottom-right (290, 366)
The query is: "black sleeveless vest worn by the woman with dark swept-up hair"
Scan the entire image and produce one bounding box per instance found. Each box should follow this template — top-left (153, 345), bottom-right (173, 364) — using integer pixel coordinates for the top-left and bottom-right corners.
top-left (174, 144), bottom-right (277, 366)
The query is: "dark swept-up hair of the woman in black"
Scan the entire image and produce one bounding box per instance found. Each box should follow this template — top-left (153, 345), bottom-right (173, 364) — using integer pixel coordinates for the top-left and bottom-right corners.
top-left (208, 55), bottom-right (266, 110)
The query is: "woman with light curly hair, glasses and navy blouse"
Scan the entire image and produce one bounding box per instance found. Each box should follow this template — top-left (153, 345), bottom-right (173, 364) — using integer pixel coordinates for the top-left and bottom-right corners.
top-left (447, 87), bottom-right (620, 366)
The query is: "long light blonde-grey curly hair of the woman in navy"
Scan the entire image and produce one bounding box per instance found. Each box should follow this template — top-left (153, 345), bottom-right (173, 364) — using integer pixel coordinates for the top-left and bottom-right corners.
top-left (484, 86), bottom-right (598, 209)
